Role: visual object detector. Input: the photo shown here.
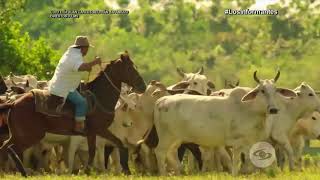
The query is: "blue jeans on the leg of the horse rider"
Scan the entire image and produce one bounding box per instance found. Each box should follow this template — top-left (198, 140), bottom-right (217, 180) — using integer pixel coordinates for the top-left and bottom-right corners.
top-left (67, 90), bottom-right (88, 121)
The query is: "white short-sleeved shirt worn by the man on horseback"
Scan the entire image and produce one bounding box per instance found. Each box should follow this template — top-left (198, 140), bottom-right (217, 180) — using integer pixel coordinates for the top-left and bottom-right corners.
top-left (48, 47), bottom-right (83, 98)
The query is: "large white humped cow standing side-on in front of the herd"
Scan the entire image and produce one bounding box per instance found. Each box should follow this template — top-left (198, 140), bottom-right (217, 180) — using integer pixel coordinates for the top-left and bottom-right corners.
top-left (154, 72), bottom-right (296, 175)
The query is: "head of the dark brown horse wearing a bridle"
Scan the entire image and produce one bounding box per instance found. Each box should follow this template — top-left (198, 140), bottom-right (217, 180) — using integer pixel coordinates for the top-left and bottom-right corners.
top-left (106, 51), bottom-right (146, 93)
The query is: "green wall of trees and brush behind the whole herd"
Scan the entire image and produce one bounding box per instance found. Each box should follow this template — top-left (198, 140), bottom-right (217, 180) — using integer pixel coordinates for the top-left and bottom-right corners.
top-left (0, 0), bottom-right (320, 88)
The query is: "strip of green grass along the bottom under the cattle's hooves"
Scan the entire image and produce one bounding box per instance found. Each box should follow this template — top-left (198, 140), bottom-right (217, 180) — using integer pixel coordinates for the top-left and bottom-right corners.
top-left (0, 154), bottom-right (320, 180)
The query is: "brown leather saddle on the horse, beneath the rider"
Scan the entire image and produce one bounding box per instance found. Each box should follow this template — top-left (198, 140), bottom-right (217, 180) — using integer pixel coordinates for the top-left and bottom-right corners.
top-left (31, 89), bottom-right (96, 118)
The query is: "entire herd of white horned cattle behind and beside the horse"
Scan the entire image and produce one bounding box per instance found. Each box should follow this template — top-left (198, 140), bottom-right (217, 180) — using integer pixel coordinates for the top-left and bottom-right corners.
top-left (0, 68), bottom-right (320, 175)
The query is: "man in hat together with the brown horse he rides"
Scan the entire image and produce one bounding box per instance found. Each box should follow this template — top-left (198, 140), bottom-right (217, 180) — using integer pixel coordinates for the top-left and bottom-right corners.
top-left (0, 36), bottom-right (146, 176)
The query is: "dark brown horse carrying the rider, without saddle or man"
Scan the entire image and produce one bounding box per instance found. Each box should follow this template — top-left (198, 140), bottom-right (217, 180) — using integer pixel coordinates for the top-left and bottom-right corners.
top-left (0, 54), bottom-right (146, 175)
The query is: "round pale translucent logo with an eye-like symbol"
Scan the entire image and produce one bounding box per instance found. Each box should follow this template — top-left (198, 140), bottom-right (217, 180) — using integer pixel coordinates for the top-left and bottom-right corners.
top-left (249, 142), bottom-right (276, 168)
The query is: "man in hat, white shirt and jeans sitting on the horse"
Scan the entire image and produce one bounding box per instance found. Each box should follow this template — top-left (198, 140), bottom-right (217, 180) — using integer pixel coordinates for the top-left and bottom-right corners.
top-left (48, 36), bottom-right (101, 133)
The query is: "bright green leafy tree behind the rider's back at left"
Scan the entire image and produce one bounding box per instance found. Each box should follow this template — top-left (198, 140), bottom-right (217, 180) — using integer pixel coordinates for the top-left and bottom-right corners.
top-left (0, 1), bottom-right (58, 78)
